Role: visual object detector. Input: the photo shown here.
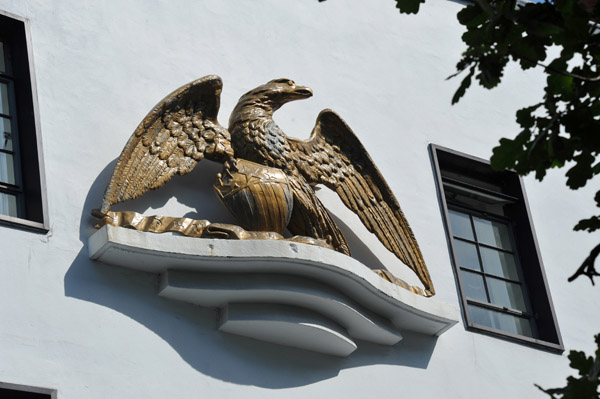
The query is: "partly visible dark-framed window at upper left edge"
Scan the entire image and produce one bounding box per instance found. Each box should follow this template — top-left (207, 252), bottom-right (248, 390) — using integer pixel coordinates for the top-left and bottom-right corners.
top-left (0, 12), bottom-right (48, 232)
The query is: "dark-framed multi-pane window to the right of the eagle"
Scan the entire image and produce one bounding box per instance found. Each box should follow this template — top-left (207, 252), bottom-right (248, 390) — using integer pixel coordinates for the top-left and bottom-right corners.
top-left (430, 145), bottom-right (563, 351)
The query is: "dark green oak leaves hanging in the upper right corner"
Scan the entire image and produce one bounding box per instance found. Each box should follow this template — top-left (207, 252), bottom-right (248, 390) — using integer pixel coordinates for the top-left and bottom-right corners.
top-left (395, 0), bottom-right (600, 283)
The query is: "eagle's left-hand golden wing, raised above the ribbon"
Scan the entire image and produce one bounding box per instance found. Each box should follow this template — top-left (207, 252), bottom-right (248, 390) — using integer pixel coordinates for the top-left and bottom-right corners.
top-left (101, 76), bottom-right (233, 214)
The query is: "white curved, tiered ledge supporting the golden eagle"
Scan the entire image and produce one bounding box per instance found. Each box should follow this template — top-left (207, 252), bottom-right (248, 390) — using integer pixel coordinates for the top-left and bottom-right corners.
top-left (89, 226), bottom-right (459, 356)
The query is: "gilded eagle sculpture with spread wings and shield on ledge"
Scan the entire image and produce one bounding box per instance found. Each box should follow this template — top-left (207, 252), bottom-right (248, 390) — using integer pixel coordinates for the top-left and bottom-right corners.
top-left (95, 76), bottom-right (435, 296)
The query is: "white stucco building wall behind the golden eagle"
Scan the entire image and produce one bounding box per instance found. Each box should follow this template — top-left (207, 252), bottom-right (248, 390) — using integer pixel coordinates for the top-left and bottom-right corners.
top-left (0, 0), bottom-right (600, 399)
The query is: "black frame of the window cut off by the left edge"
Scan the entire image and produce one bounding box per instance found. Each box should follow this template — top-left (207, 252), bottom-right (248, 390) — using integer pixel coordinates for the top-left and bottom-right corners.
top-left (0, 10), bottom-right (49, 233)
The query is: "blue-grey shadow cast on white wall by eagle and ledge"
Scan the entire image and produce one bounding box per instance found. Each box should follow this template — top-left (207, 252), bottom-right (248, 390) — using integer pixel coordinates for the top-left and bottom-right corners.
top-left (64, 162), bottom-right (437, 389)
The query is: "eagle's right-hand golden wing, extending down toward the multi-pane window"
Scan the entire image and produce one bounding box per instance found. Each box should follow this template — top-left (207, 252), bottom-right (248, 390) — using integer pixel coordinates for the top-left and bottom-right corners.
top-left (289, 109), bottom-right (435, 296)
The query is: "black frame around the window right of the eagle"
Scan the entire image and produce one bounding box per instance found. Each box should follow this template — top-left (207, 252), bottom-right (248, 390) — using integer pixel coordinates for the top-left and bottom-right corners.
top-left (429, 144), bottom-right (564, 353)
